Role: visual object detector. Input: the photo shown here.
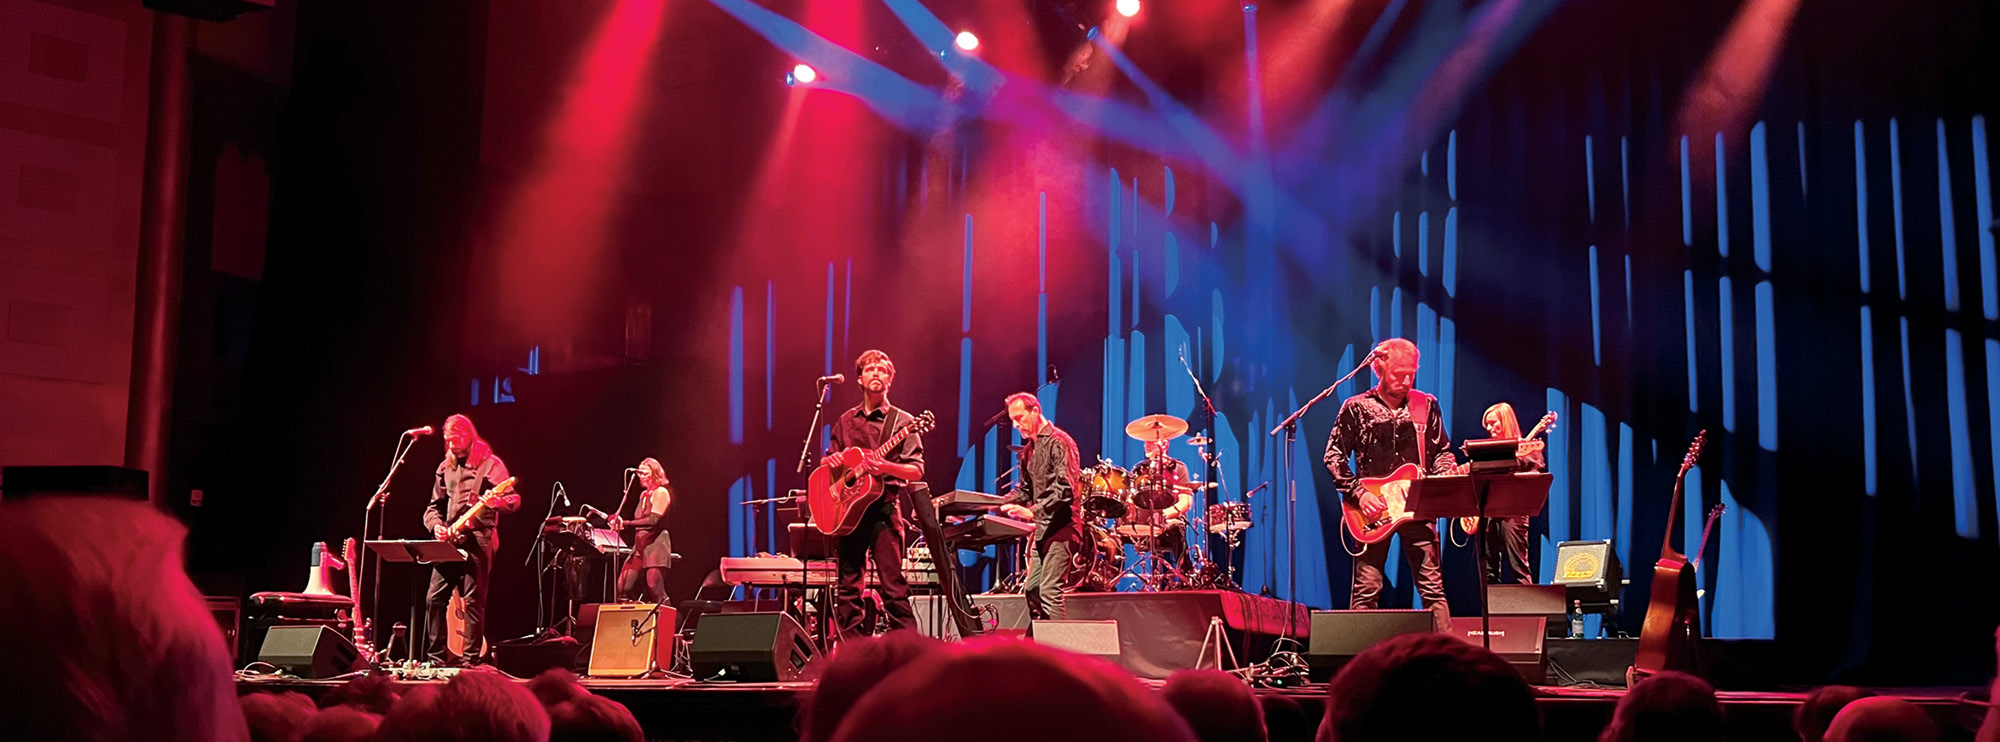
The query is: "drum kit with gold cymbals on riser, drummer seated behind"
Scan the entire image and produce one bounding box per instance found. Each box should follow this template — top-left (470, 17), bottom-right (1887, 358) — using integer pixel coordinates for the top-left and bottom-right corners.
top-left (1070, 414), bottom-right (1250, 592)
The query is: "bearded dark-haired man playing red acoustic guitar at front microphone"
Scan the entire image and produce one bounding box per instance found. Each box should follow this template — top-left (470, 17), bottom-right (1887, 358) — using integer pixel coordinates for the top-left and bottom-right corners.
top-left (822, 350), bottom-right (924, 636)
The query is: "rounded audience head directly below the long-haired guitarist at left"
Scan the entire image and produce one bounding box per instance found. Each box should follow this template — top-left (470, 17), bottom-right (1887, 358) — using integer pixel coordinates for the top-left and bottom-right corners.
top-left (376, 672), bottom-right (548, 742)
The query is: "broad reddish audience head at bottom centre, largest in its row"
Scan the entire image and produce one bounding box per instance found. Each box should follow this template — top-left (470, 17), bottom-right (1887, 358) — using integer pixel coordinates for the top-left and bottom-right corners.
top-left (834, 640), bottom-right (1194, 742)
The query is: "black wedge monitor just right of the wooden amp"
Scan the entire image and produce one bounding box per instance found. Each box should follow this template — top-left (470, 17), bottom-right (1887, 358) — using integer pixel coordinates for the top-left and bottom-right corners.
top-left (688, 612), bottom-right (816, 682)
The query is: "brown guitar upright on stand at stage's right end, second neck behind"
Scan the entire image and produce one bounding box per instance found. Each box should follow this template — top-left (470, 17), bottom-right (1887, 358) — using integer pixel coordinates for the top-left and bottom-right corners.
top-left (1626, 430), bottom-right (1724, 688)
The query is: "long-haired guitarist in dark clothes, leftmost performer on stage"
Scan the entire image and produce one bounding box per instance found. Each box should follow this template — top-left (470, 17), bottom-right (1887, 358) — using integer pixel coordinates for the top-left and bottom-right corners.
top-left (424, 414), bottom-right (520, 664)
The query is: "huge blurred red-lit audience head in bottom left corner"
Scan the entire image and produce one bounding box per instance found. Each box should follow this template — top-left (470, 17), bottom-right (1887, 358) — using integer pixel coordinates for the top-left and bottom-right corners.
top-left (0, 498), bottom-right (250, 742)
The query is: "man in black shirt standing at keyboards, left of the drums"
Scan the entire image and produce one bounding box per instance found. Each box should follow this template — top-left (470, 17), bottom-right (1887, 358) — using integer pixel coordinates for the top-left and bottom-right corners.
top-left (1000, 392), bottom-right (1090, 618)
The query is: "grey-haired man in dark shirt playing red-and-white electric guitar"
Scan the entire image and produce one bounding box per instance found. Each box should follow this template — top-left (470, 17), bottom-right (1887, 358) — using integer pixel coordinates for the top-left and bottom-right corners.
top-left (1324, 338), bottom-right (1454, 626)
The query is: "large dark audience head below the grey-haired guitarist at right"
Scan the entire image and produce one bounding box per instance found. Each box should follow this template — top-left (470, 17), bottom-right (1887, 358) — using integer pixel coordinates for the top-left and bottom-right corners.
top-left (1318, 634), bottom-right (1542, 742)
